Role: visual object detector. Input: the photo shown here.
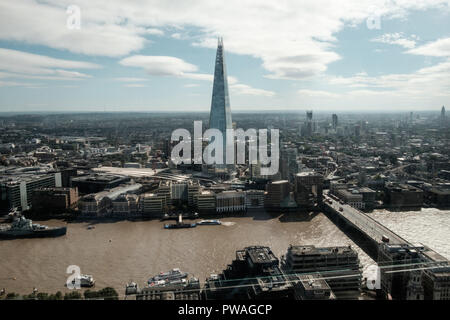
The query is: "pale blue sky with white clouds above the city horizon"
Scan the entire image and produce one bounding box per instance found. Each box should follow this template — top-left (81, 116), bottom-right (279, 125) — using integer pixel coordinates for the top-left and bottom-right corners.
top-left (0, 0), bottom-right (450, 112)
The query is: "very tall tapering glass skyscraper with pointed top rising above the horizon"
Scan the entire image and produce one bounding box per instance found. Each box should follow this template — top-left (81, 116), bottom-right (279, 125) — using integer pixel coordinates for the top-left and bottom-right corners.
top-left (209, 38), bottom-right (232, 168)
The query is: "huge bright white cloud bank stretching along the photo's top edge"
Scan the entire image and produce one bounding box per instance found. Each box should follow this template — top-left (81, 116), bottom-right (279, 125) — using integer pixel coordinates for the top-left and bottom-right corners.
top-left (0, 0), bottom-right (449, 79)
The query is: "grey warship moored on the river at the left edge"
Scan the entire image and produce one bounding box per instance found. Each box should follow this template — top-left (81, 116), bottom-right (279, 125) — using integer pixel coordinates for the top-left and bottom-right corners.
top-left (0, 216), bottom-right (67, 239)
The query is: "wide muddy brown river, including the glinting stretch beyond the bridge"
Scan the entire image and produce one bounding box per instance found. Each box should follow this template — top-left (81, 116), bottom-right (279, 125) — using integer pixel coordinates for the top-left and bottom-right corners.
top-left (0, 209), bottom-right (450, 295)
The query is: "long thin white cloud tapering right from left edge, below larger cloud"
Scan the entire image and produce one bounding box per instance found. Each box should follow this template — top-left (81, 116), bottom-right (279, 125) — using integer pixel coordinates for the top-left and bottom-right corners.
top-left (0, 48), bottom-right (100, 80)
